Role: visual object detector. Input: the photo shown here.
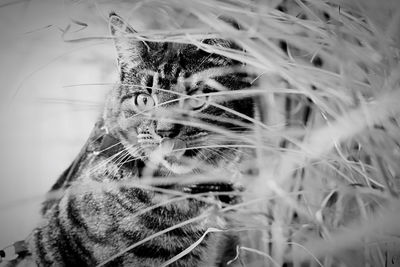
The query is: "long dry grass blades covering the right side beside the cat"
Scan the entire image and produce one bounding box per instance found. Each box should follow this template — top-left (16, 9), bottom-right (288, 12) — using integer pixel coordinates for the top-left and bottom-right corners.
top-left (3, 0), bottom-right (400, 267)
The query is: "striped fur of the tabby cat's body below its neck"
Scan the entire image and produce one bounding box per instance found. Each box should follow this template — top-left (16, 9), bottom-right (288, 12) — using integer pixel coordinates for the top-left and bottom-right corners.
top-left (30, 158), bottom-right (231, 266)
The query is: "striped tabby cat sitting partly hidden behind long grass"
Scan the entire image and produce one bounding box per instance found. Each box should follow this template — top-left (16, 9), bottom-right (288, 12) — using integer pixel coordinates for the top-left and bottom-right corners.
top-left (6, 13), bottom-right (255, 266)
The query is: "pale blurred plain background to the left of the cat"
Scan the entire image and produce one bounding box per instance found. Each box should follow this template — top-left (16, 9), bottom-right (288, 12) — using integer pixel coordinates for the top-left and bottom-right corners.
top-left (0, 0), bottom-right (126, 248)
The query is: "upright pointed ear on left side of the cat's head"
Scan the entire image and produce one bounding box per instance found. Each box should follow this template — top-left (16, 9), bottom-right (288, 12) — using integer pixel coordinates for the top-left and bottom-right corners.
top-left (109, 13), bottom-right (146, 78)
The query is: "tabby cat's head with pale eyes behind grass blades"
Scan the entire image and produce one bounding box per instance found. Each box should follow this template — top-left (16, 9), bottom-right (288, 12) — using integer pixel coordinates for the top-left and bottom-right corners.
top-left (104, 15), bottom-right (254, 174)
